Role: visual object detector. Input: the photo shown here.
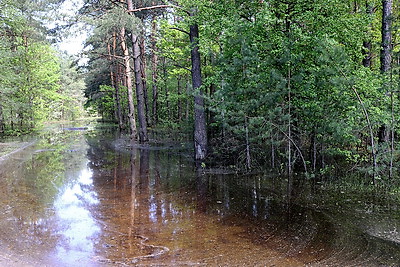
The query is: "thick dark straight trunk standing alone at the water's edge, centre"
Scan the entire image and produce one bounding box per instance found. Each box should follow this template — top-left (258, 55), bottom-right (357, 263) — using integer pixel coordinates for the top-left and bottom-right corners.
top-left (190, 24), bottom-right (207, 161)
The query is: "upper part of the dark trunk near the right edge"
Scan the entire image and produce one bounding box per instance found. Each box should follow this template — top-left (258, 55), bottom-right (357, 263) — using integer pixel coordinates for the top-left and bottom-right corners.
top-left (381, 0), bottom-right (393, 73)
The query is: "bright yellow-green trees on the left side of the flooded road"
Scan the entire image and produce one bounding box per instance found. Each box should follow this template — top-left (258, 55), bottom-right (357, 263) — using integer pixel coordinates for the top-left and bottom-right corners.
top-left (0, 0), bottom-right (84, 135)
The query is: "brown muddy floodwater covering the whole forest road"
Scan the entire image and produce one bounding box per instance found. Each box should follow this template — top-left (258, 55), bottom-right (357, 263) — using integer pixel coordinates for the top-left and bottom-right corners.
top-left (0, 128), bottom-right (400, 266)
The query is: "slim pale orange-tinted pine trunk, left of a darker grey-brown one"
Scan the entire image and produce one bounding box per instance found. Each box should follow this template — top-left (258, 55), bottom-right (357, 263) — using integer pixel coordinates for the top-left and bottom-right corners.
top-left (120, 28), bottom-right (137, 141)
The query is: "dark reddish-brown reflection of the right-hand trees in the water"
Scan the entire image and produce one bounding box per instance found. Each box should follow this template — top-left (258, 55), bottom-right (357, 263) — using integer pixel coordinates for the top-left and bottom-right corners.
top-left (82, 129), bottom-right (400, 263)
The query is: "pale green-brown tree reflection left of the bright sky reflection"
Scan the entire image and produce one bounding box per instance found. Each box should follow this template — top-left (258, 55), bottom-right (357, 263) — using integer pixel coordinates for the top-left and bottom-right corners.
top-left (0, 131), bottom-right (91, 258)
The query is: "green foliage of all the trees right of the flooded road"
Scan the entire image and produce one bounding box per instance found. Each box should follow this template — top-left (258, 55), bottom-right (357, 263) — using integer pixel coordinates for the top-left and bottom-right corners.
top-left (77, 0), bottom-right (400, 184)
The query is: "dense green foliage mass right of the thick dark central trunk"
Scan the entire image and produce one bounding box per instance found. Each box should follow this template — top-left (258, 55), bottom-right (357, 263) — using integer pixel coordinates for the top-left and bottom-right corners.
top-left (193, 0), bottom-right (389, 178)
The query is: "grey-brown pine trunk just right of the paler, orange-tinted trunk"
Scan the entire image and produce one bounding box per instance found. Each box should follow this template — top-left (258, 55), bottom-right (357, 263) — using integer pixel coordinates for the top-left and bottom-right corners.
top-left (126, 0), bottom-right (149, 143)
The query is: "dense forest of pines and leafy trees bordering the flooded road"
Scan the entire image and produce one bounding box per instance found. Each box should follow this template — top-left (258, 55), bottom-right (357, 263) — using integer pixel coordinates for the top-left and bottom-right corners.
top-left (0, 0), bottom-right (400, 185)
